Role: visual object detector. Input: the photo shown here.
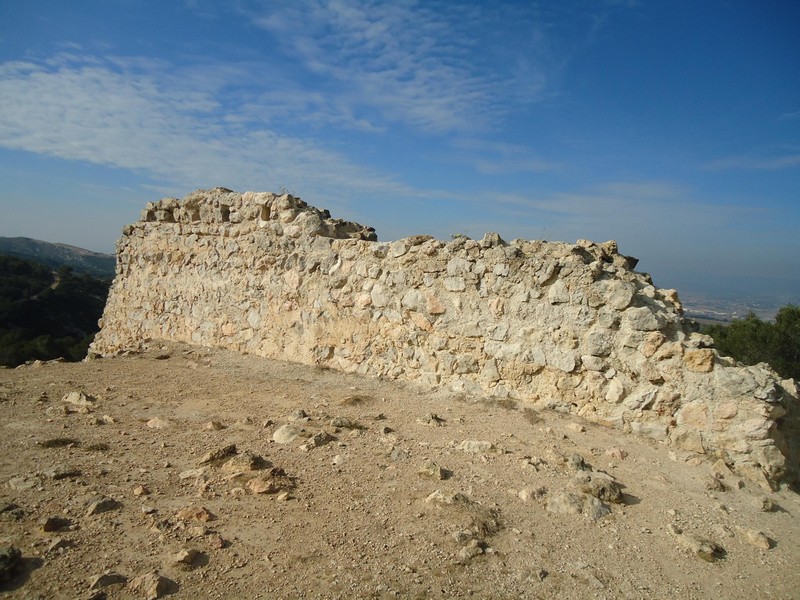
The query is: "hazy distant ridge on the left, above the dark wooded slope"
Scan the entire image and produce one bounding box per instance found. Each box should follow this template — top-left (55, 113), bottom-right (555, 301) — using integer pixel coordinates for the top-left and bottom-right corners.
top-left (0, 237), bottom-right (116, 279)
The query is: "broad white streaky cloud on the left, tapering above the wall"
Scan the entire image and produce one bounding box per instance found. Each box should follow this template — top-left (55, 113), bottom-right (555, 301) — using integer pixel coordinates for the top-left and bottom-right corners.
top-left (0, 55), bottom-right (412, 200)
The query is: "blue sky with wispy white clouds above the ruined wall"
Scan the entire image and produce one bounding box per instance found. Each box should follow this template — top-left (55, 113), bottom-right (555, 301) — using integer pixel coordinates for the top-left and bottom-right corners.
top-left (0, 0), bottom-right (800, 303)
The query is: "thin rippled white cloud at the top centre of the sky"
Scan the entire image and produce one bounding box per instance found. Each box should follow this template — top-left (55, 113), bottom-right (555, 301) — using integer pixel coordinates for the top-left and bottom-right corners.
top-left (246, 0), bottom-right (548, 132)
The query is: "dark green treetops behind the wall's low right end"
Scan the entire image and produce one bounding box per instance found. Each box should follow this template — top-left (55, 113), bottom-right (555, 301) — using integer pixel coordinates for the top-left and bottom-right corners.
top-left (703, 304), bottom-right (800, 379)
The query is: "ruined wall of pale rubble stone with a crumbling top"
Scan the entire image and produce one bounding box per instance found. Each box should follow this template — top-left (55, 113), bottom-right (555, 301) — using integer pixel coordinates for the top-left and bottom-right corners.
top-left (91, 188), bottom-right (797, 484)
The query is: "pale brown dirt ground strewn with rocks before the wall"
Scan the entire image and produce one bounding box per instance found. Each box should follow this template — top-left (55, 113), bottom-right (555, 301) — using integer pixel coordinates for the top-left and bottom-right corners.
top-left (0, 345), bottom-right (800, 599)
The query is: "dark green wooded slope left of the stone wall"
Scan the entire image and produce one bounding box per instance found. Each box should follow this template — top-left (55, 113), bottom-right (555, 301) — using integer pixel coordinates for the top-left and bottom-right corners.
top-left (0, 256), bottom-right (111, 367)
